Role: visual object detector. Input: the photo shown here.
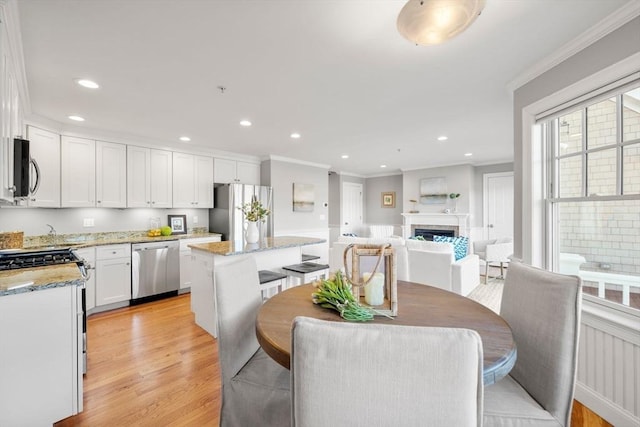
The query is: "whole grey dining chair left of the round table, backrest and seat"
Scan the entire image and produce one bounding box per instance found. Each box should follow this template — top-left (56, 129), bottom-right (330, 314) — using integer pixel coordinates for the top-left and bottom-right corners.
top-left (214, 257), bottom-right (291, 427)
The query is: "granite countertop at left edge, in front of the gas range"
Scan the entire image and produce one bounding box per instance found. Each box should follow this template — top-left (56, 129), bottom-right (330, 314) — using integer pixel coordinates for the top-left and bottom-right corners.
top-left (0, 263), bottom-right (84, 297)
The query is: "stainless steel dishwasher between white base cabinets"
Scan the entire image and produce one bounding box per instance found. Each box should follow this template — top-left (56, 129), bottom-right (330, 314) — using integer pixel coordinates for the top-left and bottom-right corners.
top-left (131, 240), bottom-right (180, 300)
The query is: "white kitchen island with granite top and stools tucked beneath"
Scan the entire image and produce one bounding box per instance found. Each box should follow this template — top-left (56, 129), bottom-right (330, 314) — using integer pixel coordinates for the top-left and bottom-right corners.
top-left (189, 236), bottom-right (326, 337)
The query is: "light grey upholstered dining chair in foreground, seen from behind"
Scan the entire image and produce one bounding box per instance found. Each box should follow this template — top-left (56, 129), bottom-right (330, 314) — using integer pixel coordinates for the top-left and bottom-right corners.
top-left (291, 317), bottom-right (483, 427)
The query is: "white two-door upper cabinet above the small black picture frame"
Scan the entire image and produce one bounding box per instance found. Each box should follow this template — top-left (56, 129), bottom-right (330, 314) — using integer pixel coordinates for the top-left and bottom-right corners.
top-left (173, 152), bottom-right (213, 208)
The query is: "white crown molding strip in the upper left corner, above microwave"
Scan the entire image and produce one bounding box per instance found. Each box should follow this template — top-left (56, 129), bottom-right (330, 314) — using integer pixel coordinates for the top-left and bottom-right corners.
top-left (0, 0), bottom-right (31, 114)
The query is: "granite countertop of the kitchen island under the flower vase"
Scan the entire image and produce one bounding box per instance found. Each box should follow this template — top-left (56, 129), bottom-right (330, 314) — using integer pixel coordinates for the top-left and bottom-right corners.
top-left (189, 236), bottom-right (326, 256)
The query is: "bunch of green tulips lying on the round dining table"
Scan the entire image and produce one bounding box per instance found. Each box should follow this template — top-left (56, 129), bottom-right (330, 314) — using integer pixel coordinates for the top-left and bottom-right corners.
top-left (311, 270), bottom-right (375, 322)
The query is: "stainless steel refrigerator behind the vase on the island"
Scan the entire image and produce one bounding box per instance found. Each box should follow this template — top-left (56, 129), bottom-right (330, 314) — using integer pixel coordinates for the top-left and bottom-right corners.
top-left (209, 184), bottom-right (273, 244)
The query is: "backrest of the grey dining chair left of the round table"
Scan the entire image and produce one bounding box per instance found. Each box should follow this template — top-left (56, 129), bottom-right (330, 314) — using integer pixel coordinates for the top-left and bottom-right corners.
top-left (214, 257), bottom-right (262, 384)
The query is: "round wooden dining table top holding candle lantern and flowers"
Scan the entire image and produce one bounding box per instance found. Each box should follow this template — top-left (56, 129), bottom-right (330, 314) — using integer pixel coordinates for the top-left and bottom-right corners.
top-left (256, 281), bottom-right (517, 385)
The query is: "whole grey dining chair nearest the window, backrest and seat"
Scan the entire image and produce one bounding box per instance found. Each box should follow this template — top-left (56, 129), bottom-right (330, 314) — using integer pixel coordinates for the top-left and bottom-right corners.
top-left (484, 261), bottom-right (582, 427)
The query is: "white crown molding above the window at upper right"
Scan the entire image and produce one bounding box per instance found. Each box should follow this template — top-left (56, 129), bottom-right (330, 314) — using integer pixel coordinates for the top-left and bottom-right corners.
top-left (507, 0), bottom-right (640, 93)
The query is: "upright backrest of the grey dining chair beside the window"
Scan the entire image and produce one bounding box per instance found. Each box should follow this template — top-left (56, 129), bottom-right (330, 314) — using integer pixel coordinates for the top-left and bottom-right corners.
top-left (500, 262), bottom-right (582, 425)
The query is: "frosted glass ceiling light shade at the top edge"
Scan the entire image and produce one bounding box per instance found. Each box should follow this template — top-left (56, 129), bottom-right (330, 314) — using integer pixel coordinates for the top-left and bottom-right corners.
top-left (397, 0), bottom-right (485, 45)
